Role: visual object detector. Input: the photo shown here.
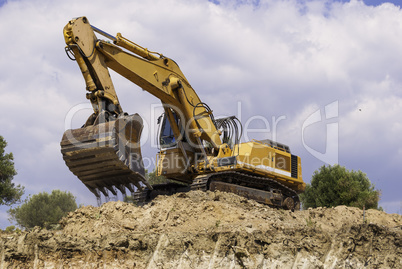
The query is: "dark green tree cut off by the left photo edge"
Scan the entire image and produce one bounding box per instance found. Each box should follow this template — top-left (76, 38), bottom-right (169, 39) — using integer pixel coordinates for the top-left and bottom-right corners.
top-left (0, 136), bottom-right (24, 206)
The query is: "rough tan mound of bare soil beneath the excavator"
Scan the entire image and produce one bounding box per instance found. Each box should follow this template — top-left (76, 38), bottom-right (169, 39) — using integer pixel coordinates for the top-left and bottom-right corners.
top-left (0, 191), bottom-right (402, 268)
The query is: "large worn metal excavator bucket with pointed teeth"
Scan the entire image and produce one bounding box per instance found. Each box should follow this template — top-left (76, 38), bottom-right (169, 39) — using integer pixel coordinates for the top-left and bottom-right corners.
top-left (60, 114), bottom-right (148, 203)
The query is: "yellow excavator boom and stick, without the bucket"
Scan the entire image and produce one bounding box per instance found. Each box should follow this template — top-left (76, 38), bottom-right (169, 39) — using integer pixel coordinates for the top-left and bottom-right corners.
top-left (64, 17), bottom-right (222, 151)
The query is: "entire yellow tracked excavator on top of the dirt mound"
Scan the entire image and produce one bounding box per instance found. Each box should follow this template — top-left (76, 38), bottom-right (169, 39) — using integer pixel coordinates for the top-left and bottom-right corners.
top-left (60, 17), bottom-right (305, 210)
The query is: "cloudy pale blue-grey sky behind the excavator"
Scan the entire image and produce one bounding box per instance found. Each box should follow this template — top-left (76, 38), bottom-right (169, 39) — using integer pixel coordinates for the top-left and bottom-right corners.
top-left (0, 0), bottom-right (402, 229)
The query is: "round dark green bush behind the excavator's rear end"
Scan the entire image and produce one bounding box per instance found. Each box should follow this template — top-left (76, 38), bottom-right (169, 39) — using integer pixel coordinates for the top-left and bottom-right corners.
top-left (300, 165), bottom-right (380, 209)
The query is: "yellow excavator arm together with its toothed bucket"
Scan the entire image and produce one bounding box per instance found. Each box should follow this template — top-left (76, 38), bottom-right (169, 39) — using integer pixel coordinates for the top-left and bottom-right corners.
top-left (61, 17), bottom-right (230, 199)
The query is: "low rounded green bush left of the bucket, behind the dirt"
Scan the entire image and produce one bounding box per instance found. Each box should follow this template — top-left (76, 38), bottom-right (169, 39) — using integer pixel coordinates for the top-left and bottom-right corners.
top-left (8, 190), bottom-right (77, 229)
